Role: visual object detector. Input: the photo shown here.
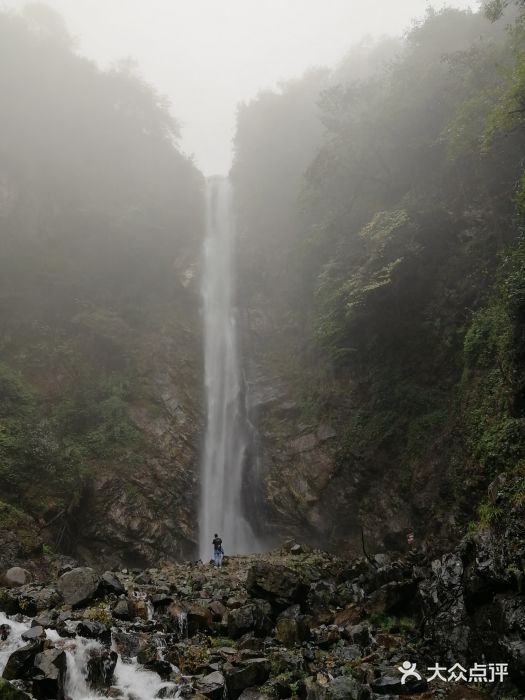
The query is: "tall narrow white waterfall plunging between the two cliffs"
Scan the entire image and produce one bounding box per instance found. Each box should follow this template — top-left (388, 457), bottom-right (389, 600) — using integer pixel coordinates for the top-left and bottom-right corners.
top-left (199, 177), bottom-right (256, 561)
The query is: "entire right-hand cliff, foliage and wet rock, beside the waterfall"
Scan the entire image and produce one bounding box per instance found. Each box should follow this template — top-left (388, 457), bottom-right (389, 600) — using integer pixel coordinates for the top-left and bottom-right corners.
top-left (232, 8), bottom-right (525, 551)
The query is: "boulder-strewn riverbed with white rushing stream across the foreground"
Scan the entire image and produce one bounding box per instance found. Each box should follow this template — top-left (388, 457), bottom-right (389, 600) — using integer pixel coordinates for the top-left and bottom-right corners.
top-left (0, 535), bottom-right (525, 700)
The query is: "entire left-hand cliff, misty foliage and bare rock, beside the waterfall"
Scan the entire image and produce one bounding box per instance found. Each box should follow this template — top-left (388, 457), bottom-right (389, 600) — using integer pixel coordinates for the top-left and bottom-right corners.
top-left (0, 10), bottom-right (204, 566)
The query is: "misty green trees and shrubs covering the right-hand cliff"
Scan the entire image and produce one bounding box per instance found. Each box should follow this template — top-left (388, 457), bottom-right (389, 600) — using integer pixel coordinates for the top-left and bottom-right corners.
top-left (234, 3), bottom-right (525, 540)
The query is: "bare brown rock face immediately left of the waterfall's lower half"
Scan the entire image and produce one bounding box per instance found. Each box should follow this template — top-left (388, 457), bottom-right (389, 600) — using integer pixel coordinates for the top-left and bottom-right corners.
top-left (68, 308), bottom-right (203, 566)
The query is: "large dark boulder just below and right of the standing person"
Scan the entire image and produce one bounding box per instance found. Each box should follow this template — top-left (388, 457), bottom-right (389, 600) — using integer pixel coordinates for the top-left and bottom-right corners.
top-left (246, 561), bottom-right (309, 608)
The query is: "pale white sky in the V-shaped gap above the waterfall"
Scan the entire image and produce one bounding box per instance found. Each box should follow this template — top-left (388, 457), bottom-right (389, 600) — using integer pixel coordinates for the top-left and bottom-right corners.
top-left (0, 0), bottom-right (478, 175)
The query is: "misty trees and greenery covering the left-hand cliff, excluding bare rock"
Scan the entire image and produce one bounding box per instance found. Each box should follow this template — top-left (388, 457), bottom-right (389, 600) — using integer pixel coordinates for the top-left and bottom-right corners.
top-left (0, 5), bottom-right (203, 552)
